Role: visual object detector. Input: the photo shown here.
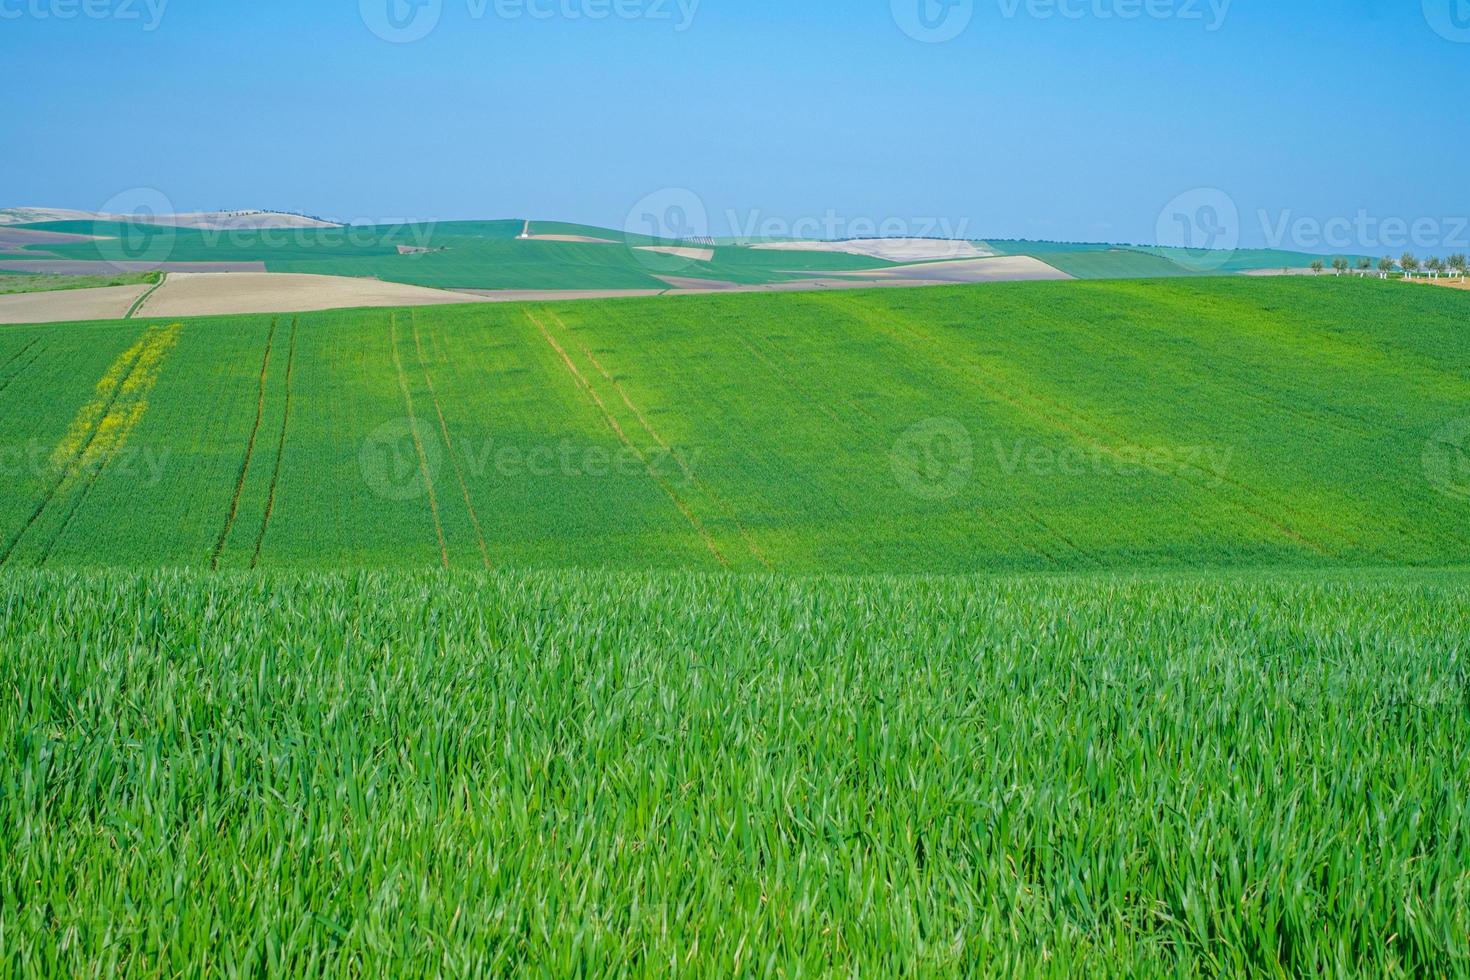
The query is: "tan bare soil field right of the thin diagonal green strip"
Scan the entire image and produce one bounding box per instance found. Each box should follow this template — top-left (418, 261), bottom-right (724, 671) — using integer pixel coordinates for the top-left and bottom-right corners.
top-left (138, 272), bottom-right (499, 316)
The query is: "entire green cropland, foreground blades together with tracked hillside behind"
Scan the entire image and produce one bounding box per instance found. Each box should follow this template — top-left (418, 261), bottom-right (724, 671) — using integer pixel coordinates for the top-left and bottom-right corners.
top-left (0, 274), bottom-right (1470, 976)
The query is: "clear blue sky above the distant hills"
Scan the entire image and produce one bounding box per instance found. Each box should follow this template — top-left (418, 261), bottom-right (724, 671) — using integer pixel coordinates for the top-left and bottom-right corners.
top-left (0, 0), bottom-right (1470, 253)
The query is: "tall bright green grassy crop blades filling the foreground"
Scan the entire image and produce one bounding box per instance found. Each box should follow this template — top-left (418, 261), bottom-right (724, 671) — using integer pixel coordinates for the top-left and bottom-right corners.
top-left (0, 572), bottom-right (1470, 976)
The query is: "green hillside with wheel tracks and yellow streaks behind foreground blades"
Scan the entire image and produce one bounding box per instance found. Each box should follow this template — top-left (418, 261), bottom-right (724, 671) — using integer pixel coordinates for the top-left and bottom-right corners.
top-left (0, 279), bottom-right (1470, 573)
